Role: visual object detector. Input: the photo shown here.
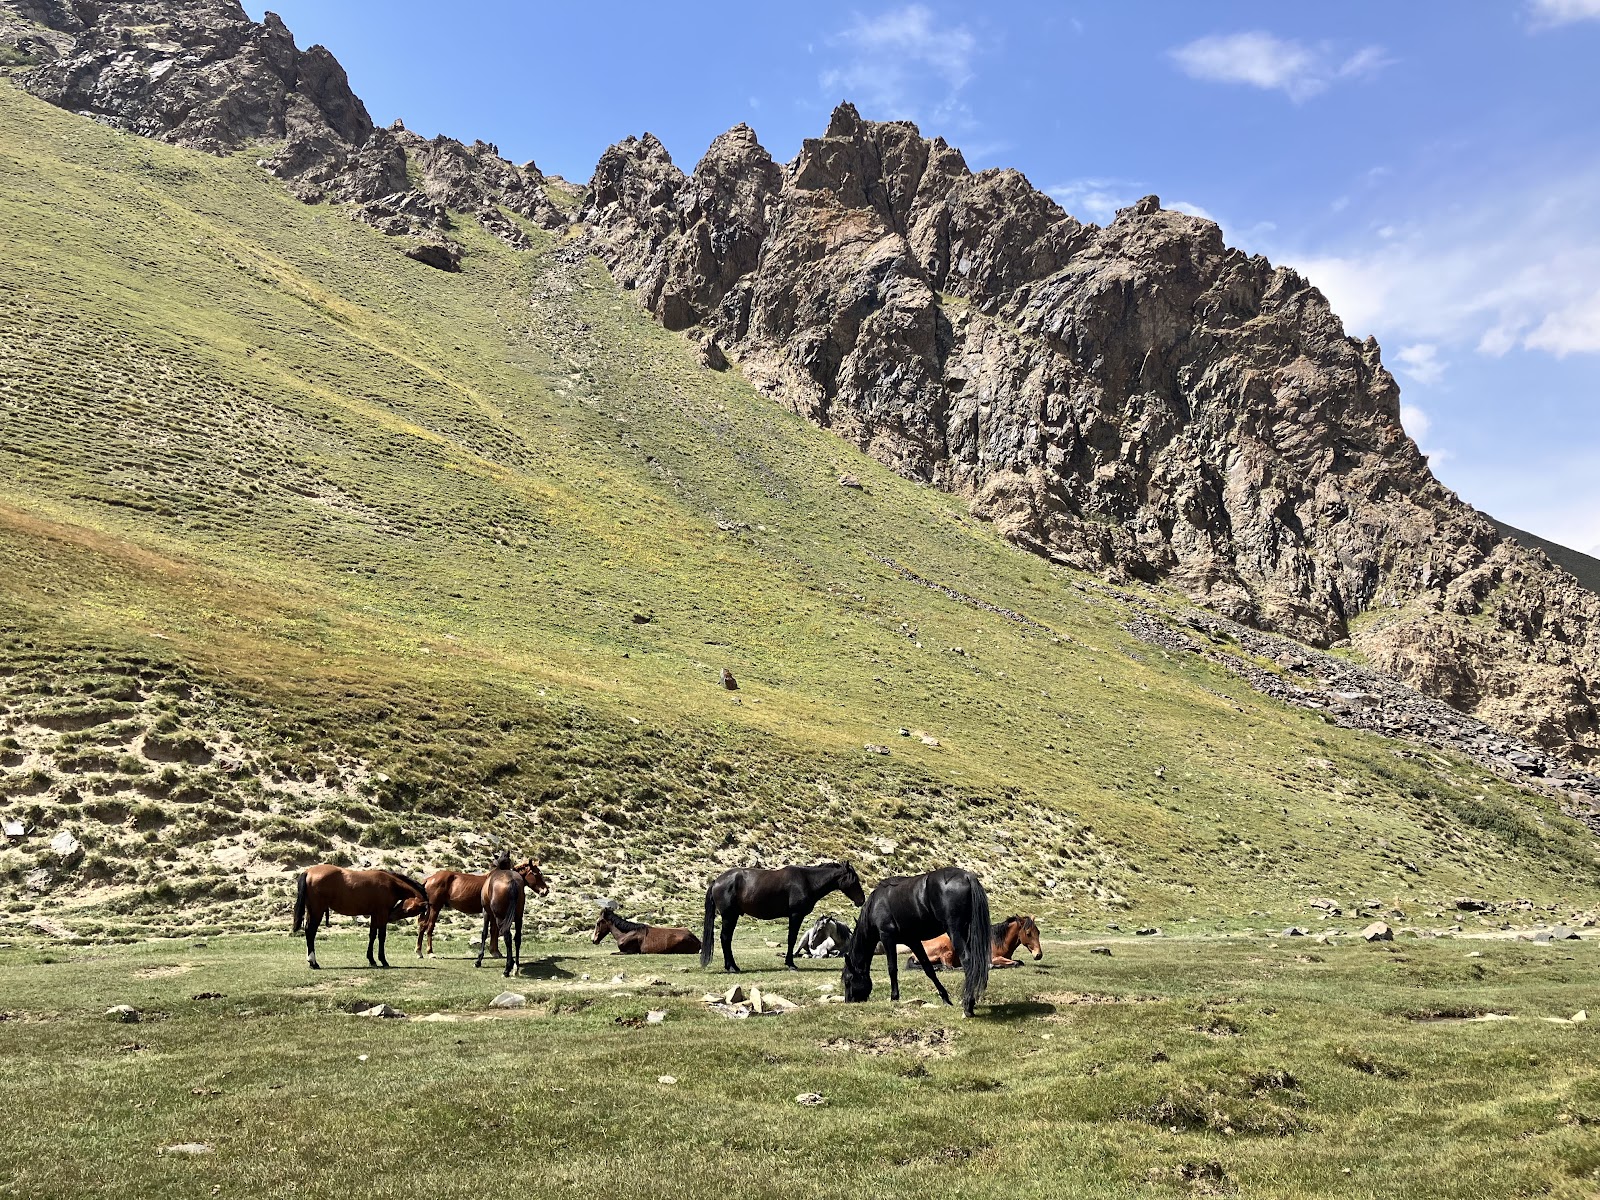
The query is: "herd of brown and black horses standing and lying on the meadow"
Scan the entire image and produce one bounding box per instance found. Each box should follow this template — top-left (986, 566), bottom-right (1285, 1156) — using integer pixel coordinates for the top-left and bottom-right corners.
top-left (294, 853), bottom-right (1043, 1016)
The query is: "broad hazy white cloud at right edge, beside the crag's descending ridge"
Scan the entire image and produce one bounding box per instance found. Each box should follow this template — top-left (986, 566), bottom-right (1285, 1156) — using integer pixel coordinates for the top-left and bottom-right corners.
top-left (1272, 166), bottom-right (1600, 361)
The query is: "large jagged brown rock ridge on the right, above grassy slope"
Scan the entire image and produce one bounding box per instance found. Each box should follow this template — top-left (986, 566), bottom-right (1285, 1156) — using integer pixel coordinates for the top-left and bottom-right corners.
top-left (581, 104), bottom-right (1600, 757)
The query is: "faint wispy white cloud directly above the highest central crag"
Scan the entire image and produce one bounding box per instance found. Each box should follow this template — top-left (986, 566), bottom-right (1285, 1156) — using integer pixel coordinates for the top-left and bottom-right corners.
top-left (818, 3), bottom-right (981, 128)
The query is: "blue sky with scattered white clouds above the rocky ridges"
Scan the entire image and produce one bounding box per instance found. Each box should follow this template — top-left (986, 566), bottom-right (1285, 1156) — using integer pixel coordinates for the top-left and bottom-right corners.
top-left (248, 0), bottom-right (1600, 554)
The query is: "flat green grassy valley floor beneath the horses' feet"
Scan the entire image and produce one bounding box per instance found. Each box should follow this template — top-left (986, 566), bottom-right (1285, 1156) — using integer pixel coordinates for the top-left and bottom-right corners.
top-left (0, 918), bottom-right (1600, 1200)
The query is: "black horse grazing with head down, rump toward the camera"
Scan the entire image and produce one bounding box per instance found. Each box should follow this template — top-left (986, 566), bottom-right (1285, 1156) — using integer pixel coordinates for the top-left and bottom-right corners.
top-left (843, 867), bottom-right (990, 1016)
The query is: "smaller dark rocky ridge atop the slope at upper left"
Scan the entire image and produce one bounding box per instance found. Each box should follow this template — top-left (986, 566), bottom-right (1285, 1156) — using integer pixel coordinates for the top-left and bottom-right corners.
top-left (0, 0), bottom-right (566, 249)
